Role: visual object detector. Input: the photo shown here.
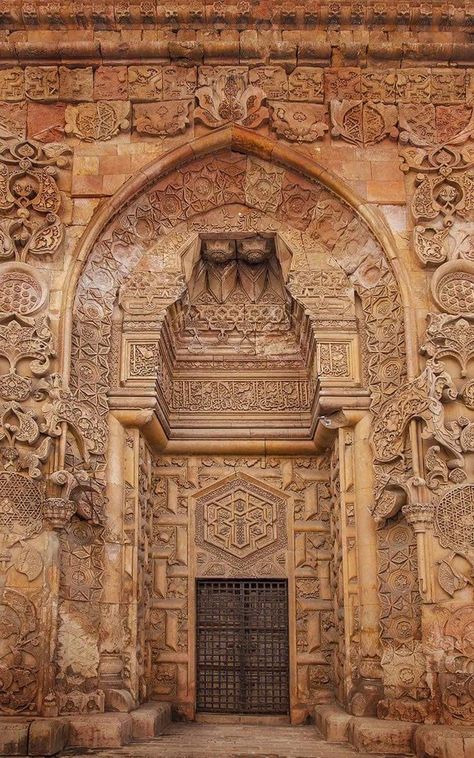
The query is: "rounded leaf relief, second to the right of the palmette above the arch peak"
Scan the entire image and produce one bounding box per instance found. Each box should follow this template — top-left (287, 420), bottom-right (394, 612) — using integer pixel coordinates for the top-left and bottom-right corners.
top-left (331, 100), bottom-right (398, 147)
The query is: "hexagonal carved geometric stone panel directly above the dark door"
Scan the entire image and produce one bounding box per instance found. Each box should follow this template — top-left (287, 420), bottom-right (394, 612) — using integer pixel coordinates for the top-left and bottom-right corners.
top-left (196, 474), bottom-right (287, 572)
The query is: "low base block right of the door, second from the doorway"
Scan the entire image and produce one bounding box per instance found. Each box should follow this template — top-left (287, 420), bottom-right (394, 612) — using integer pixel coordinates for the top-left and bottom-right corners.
top-left (349, 718), bottom-right (415, 755)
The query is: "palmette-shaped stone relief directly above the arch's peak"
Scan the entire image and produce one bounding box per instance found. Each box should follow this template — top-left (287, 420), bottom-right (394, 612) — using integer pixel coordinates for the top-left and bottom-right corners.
top-left (194, 73), bottom-right (268, 128)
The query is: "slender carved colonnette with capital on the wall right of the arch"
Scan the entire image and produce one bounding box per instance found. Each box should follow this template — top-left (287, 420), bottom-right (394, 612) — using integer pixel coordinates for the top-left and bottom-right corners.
top-left (402, 477), bottom-right (435, 603)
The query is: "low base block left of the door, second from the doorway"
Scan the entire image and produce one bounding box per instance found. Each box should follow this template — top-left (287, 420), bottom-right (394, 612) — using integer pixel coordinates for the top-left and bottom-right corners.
top-left (68, 713), bottom-right (132, 749)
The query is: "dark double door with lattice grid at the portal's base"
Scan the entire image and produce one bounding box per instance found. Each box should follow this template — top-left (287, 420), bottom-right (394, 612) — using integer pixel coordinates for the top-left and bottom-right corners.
top-left (196, 579), bottom-right (288, 713)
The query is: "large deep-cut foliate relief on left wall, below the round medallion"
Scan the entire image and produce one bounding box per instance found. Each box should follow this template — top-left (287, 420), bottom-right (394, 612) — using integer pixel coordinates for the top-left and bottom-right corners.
top-left (0, 302), bottom-right (104, 536)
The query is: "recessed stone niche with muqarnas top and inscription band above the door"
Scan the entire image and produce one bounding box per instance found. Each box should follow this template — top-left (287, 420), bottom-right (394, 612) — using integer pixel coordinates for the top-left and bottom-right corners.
top-left (115, 233), bottom-right (358, 438)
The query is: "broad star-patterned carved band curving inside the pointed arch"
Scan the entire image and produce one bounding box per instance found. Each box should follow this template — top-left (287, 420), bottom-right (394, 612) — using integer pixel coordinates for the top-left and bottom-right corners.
top-left (71, 137), bottom-right (405, 524)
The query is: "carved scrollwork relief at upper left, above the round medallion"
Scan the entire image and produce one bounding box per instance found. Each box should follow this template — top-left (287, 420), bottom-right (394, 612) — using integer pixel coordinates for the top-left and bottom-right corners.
top-left (0, 139), bottom-right (71, 261)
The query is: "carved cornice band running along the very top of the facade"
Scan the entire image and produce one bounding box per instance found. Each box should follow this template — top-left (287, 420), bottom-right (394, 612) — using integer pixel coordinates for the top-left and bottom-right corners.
top-left (0, 0), bottom-right (474, 31)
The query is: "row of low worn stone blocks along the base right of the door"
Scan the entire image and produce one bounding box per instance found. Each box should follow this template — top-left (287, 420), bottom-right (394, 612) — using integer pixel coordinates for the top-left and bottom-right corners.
top-left (314, 705), bottom-right (474, 758)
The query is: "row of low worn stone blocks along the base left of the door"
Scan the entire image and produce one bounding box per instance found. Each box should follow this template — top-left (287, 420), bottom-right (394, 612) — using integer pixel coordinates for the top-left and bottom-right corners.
top-left (0, 702), bottom-right (171, 756)
